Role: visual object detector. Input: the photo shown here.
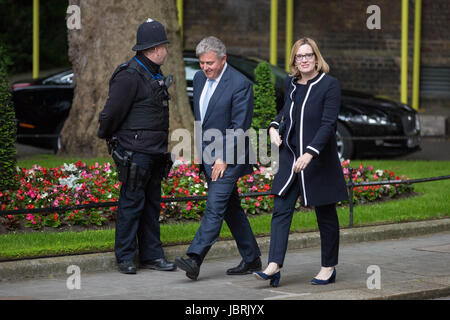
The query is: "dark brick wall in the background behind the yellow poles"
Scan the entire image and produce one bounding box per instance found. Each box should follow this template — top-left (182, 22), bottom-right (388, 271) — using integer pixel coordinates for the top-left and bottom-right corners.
top-left (183, 0), bottom-right (450, 109)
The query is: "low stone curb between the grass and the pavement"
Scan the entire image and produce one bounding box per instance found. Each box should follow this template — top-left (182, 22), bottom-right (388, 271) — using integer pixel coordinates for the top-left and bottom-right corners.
top-left (0, 219), bottom-right (450, 284)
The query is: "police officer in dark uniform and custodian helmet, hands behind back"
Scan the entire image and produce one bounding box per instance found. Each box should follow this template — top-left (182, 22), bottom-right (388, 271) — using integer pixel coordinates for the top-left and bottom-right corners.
top-left (98, 19), bottom-right (176, 274)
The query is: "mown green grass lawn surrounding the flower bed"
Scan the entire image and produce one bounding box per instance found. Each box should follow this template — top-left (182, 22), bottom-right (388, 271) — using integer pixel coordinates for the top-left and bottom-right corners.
top-left (0, 157), bottom-right (450, 260)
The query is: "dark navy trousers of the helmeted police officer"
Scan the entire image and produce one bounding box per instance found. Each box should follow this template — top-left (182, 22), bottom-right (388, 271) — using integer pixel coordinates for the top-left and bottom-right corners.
top-left (114, 147), bottom-right (164, 263)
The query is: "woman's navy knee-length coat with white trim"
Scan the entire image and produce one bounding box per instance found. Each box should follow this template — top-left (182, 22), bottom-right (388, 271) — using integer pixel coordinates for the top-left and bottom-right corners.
top-left (269, 72), bottom-right (348, 206)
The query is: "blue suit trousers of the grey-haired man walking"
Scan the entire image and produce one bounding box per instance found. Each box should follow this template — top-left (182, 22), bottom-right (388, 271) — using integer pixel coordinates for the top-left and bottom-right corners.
top-left (186, 178), bottom-right (261, 263)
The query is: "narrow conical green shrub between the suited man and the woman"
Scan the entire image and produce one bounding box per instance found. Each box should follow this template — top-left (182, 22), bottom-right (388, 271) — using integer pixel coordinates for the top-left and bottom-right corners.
top-left (252, 62), bottom-right (277, 131)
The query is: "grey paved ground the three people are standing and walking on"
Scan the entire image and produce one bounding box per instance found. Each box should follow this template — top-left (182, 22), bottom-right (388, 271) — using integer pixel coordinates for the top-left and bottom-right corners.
top-left (0, 231), bottom-right (450, 301)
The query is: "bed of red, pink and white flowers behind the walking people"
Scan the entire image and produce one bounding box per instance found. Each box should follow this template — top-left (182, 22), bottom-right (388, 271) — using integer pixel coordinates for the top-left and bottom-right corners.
top-left (0, 160), bottom-right (413, 230)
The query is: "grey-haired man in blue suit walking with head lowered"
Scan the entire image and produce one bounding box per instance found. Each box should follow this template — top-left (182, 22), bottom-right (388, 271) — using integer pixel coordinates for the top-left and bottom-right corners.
top-left (175, 37), bottom-right (261, 280)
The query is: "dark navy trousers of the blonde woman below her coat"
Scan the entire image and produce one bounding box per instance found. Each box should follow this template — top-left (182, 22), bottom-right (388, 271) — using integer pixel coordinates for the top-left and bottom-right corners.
top-left (269, 179), bottom-right (339, 267)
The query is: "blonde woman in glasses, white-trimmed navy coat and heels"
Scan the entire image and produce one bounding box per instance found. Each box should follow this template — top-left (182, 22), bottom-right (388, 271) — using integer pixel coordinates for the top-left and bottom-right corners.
top-left (254, 38), bottom-right (348, 286)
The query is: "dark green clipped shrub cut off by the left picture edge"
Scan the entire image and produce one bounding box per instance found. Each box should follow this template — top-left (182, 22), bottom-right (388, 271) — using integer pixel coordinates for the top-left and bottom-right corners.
top-left (0, 44), bottom-right (18, 190)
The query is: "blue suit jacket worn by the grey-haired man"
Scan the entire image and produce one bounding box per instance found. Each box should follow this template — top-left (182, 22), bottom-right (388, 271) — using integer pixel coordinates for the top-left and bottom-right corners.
top-left (193, 64), bottom-right (253, 182)
